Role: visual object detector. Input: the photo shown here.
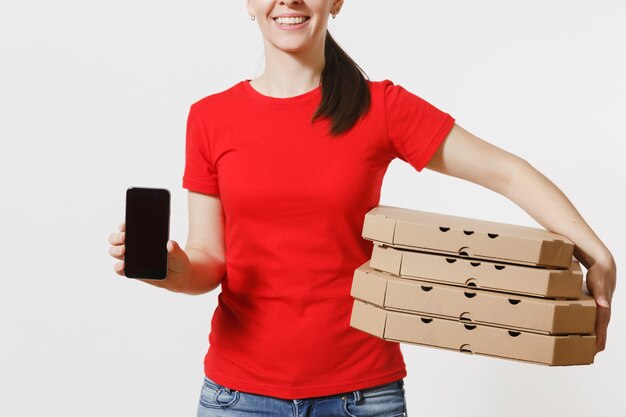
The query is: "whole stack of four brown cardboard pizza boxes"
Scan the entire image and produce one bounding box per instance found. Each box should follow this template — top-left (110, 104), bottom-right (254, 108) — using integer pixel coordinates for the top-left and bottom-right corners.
top-left (350, 205), bottom-right (596, 366)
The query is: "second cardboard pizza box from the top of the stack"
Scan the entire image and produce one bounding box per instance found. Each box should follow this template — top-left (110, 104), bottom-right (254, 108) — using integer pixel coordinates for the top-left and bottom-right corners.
top-left (369, 244), bottom-right (583, 299)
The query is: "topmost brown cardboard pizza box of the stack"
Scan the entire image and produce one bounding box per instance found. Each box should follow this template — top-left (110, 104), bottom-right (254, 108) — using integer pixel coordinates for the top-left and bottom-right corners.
top-left (362, 205), bottom-right (574, 268)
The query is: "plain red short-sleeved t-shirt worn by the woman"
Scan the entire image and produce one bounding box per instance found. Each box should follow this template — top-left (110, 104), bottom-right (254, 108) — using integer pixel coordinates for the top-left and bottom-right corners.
top-left (182, 76), bottom-right (454, 399)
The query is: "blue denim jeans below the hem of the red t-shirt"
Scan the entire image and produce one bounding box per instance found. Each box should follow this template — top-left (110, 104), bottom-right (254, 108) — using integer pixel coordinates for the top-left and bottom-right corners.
top-left (196, 377), bottom-right (407, 417)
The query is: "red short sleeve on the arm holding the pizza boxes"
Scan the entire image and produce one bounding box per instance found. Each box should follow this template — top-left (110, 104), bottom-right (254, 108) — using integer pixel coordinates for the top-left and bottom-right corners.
top-left (383, 80), bottom-right (455, 171)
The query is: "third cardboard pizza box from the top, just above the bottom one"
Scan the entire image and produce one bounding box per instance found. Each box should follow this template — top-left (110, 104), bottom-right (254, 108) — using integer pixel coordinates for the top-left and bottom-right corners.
top-left (351, 262), bottom-right (596, 334)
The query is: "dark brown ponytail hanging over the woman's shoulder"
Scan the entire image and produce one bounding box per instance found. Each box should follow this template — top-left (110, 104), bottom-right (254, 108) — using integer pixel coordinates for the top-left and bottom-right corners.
top-left (311, 30), bottom-right (370, 136)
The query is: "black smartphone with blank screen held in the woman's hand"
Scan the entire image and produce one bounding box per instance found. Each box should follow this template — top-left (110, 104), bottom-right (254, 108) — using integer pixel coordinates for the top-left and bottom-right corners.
top-left (124, 187), bottom-right (170, 279)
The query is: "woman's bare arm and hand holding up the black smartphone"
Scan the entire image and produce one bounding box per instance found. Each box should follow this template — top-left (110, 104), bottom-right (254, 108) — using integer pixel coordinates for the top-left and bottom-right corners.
top-left (109, 191), bottom-right (226, 295)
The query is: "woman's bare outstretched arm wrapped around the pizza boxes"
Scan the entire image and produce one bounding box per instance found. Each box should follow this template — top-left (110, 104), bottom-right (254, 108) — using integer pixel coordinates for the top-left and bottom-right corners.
top-left (426, 125), bottom-right (617, 352)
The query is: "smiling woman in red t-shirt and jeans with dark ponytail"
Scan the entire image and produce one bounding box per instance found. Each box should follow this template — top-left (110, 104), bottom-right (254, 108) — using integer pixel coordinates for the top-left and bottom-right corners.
top-left (110, 0), bottom-right (616, 416)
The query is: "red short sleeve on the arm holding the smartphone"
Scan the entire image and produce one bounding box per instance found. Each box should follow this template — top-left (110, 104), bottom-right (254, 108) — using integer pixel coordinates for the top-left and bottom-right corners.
top-left (183, 105), bottom-right (219, 195)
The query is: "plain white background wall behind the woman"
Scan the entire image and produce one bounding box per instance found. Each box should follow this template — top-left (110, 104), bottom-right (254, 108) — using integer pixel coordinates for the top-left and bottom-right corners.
top-left (0, 0), bottom-right (626, 417)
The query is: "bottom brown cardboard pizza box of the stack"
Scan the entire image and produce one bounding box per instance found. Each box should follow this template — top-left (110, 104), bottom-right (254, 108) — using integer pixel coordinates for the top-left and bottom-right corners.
top-left (350, 299), bottom-right (596, 366)
